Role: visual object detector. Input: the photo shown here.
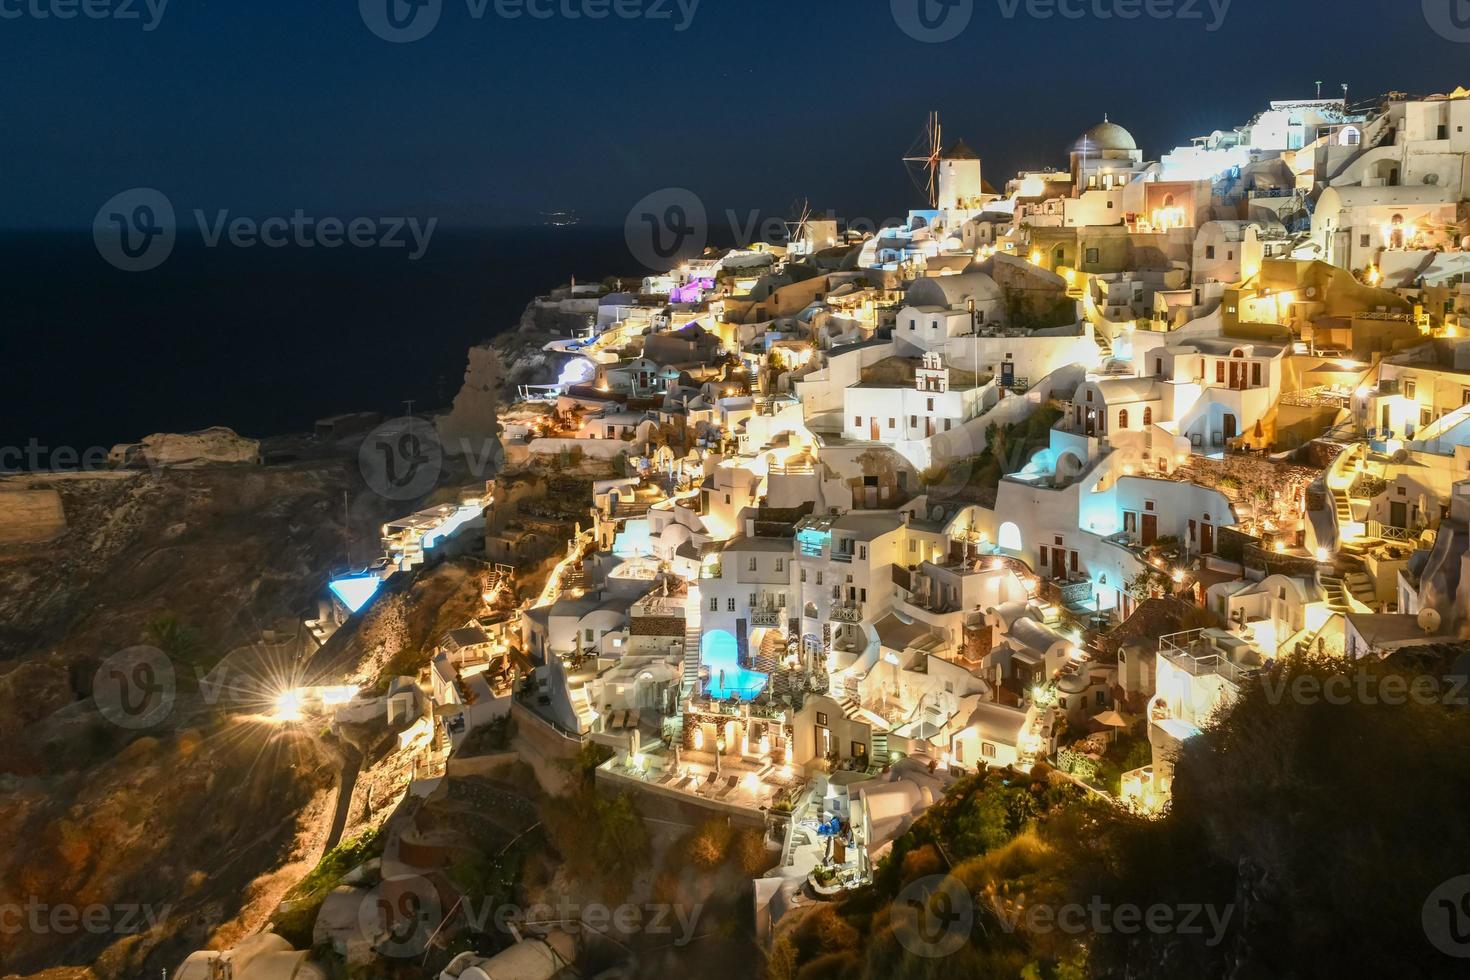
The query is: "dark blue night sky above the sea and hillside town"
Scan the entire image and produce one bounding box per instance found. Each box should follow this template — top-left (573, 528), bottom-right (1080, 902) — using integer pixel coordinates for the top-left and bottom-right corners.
top-left (0, 0), bottom-right (1470, 228)
